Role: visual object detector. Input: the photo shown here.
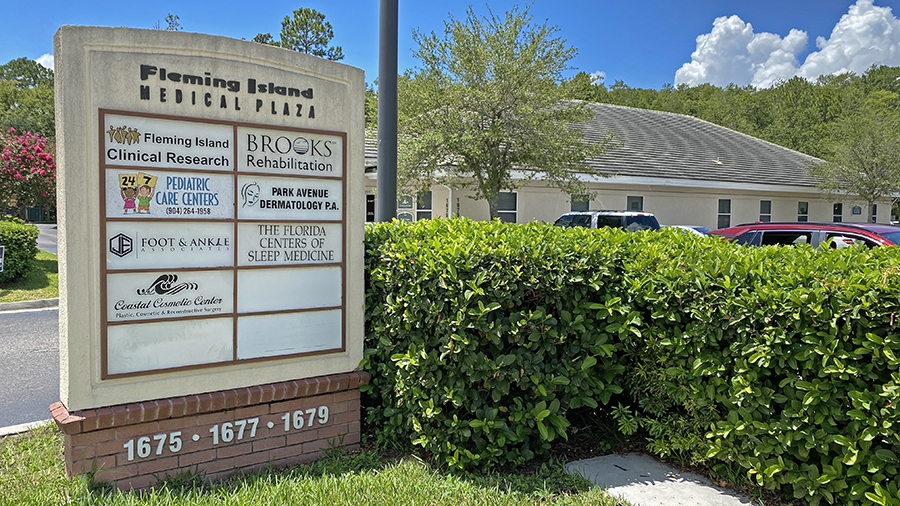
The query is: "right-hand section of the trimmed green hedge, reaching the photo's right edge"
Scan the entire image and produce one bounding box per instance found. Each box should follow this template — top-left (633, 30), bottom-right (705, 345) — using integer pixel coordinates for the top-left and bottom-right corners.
top-left (622, 237), bottom-right (900, 504)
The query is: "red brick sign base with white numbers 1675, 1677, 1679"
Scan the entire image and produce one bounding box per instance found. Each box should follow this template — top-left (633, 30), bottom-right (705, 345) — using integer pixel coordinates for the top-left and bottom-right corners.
top-left (50, 372), bottom-right (370, 490)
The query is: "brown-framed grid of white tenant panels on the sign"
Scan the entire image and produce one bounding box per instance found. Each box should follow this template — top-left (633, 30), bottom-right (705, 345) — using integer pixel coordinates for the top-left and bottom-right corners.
top-left (100, 111), bottom-right (346, 377)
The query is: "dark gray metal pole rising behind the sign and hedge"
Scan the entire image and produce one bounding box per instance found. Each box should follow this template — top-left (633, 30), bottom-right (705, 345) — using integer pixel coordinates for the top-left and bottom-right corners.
top-left (375, 0), bottom-right (398, 221)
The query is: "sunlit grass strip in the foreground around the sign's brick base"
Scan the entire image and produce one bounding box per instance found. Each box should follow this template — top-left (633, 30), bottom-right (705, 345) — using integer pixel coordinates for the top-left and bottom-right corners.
top-left (0, 425), bottom-right (627, 506)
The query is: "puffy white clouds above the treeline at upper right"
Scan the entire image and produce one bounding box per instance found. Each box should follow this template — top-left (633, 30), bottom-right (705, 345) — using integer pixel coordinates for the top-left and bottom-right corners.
top-left (675, 0), bottom-right (900, 87)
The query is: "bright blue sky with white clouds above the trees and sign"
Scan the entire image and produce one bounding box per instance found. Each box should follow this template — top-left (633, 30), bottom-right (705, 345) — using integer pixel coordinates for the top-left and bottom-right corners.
top-left (0, 0), bottom-right (900, 89)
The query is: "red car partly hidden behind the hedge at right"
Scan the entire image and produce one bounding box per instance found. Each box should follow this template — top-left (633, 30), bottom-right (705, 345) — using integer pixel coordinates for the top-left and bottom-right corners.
top-left (709, 222), bottom-right (900, 248)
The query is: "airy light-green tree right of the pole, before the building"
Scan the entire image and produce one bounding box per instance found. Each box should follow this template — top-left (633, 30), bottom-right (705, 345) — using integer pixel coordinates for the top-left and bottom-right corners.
top-left (398, 8), bottom-right (612, 218)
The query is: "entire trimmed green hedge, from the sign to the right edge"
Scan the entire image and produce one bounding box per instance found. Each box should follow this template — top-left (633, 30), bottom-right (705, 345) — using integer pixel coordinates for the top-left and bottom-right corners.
top-left (362, 219), bottom-right (900, 505)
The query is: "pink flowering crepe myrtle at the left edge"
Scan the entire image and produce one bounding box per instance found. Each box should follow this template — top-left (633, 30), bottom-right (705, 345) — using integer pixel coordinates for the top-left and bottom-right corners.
top-left (0, 128), bottom-right (56, 210)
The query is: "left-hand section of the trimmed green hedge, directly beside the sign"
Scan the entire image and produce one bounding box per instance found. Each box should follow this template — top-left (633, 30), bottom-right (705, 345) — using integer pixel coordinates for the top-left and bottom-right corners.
top-left (362, 219), bottom-right (633, 468)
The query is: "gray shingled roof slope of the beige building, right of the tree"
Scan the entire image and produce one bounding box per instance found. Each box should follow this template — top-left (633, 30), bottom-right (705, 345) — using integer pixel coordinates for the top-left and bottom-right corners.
top-left (584, 103), bottom-right (821, 186)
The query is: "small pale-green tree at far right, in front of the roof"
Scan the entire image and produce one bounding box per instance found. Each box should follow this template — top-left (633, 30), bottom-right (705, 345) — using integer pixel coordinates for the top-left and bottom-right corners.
top-left (809, 103), bottom-right (900, 214)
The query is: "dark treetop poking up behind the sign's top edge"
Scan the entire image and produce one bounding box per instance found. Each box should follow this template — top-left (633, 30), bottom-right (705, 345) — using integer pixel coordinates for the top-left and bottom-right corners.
top-left (253, 7), bottom-right (344, 61)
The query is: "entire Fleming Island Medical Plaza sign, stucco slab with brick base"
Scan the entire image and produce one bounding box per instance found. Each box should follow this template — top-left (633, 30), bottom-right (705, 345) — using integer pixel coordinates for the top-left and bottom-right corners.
top-left (54, 26), bottom-right (365, 486)
